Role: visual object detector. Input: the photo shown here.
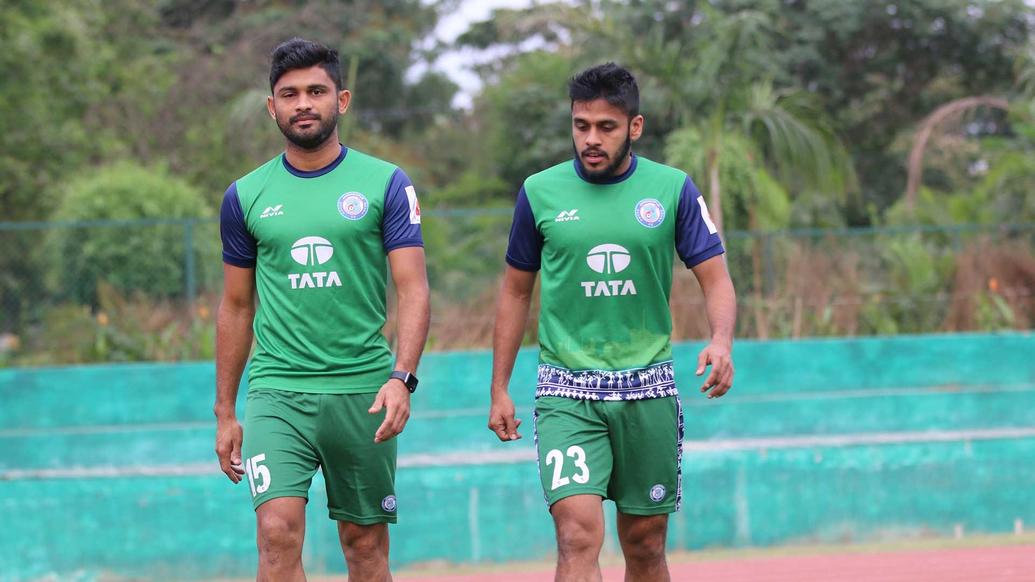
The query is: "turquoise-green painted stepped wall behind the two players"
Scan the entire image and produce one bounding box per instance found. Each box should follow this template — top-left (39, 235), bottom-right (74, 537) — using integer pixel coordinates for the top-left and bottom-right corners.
top-left (0, 333), bottom-right (1035, 580)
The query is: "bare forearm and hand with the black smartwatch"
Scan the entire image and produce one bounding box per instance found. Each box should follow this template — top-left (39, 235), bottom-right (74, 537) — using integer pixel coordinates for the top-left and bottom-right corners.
top-left (368, 246), bottom-right (431, 442)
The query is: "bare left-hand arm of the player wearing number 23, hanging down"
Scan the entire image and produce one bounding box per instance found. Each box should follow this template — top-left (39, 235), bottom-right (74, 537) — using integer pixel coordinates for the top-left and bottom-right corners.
top-left (489, 265), bottom-right (536, 441)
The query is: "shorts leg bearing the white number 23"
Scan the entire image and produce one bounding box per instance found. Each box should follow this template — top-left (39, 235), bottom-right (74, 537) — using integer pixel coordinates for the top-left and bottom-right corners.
top-left (535, 397), bottom-right (612, 505)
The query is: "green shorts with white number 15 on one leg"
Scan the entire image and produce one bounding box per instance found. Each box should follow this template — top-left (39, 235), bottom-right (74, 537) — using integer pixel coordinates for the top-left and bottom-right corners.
top-left (243, 388), bottom-right (396, 525)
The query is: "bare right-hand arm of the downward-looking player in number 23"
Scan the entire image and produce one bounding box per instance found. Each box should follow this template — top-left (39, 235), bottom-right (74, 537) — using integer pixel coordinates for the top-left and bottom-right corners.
top-left (693, 255), bottom-right (737, 398)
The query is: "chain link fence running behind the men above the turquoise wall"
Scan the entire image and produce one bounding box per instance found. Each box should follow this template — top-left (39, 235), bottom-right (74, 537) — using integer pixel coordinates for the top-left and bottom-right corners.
top-left (0, 215), bottom-right (1035, 366)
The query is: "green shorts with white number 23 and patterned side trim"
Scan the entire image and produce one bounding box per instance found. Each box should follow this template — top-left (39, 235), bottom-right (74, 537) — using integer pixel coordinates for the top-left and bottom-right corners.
top-left (535, 397), bottom-right (683, 516)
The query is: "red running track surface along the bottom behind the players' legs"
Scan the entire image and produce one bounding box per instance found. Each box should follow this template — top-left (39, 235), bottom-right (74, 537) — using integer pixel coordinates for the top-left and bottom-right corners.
top-left (396, 546), bottom-right (1035, 582)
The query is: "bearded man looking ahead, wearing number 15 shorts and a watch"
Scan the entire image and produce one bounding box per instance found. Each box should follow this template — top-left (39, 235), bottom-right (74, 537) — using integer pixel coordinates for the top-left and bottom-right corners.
top-left (215, 38), bottom-right (428, 582)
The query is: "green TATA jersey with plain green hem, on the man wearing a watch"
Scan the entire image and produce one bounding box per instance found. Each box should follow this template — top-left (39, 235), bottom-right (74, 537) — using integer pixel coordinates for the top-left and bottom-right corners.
top-left (220, 147), bottom-right (423, 394)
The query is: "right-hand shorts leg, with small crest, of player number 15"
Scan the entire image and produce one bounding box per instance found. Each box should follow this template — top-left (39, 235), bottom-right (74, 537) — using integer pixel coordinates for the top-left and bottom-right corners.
top-left (318, 392), bottom-right (400, 525)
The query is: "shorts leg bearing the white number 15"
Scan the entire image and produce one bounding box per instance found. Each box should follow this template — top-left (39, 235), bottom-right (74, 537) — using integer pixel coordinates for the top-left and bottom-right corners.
top-left (241, 389), bottom-right (319, 507)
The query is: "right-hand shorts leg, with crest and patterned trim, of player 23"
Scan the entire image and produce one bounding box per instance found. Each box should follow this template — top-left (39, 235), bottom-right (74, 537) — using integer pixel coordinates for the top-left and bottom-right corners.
top-left (605, 397), bottom-right (683, 516)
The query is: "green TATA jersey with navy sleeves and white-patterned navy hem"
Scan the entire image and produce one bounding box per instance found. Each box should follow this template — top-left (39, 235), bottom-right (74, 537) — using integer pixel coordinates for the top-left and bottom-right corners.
top-left (506, 156), bottom-right (723, 400)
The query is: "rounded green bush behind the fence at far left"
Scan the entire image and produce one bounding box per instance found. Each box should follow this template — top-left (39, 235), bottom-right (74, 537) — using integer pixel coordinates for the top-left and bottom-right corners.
top-left (50, 163), bottom-right (212, 302)
